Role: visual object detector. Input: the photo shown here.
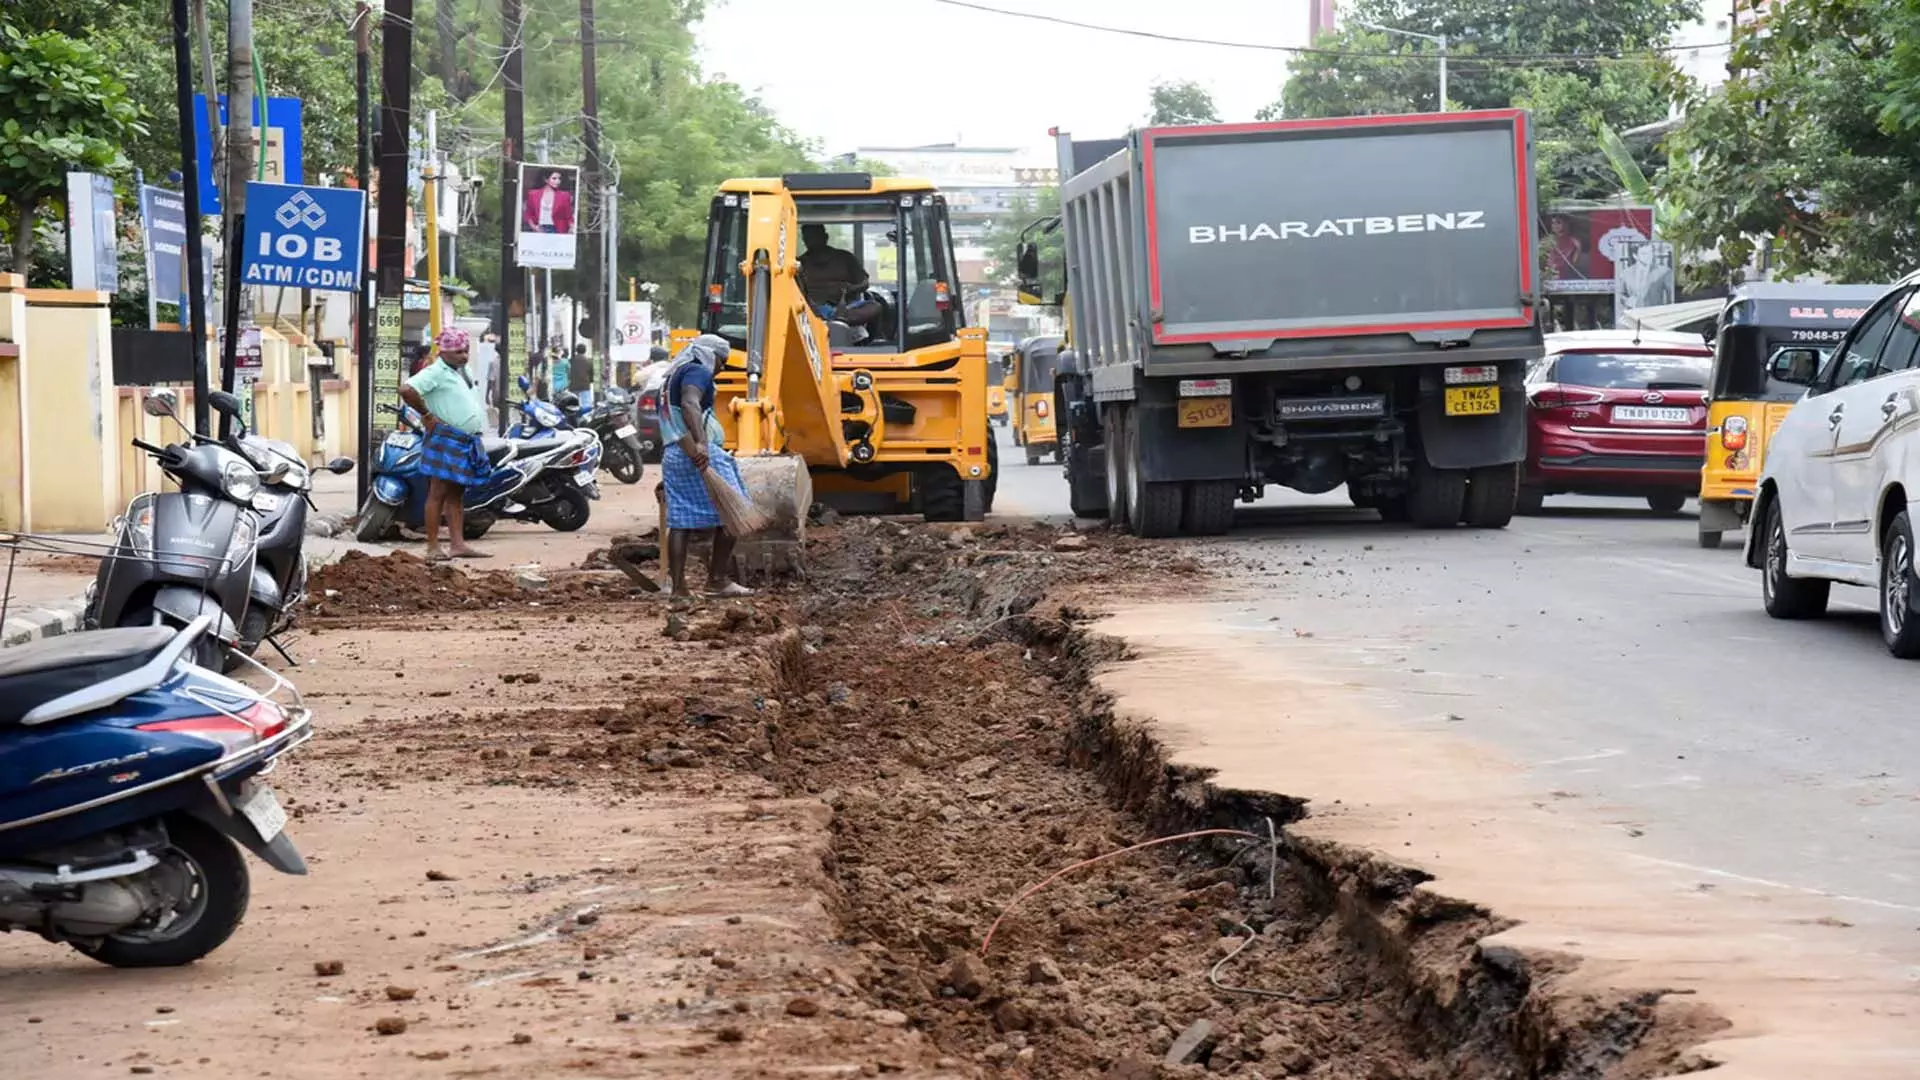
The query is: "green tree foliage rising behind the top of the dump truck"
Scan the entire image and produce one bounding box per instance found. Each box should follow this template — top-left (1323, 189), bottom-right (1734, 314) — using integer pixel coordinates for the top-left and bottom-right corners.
top-left (1260, 0), bottom-right (1699, 198)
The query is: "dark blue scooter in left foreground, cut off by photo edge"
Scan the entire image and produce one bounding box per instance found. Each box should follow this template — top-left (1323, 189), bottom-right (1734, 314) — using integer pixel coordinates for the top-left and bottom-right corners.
top-left (0, 614), bottom-right (313, 967)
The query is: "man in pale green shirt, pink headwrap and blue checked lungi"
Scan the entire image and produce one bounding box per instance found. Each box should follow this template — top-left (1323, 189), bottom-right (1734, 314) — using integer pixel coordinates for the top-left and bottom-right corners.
top-left (399, 327), bottom-right (493, 563)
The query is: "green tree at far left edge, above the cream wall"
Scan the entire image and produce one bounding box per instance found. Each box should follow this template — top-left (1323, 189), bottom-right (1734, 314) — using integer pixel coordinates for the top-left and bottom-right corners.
top-left (0, 25), bottom-right (146, 275)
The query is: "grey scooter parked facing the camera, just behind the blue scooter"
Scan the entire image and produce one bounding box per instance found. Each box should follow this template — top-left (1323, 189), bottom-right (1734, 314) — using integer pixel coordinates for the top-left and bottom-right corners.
top-left (83, 390), bottom-right (261, 669)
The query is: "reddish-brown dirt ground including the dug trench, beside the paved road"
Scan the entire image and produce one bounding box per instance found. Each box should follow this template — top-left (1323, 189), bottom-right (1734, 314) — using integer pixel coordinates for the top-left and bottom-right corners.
top-left (0, 521), bottom-right (1703, 1080)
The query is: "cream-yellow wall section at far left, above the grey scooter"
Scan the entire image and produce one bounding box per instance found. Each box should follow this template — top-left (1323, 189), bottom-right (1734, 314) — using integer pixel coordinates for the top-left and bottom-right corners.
top-left (21, 288), bottom-right (121, 532)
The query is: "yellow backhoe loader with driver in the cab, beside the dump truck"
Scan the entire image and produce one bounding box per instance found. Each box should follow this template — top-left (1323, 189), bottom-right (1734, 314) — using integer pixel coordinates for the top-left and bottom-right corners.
top-left (699, 173), bottom-right (995, 521)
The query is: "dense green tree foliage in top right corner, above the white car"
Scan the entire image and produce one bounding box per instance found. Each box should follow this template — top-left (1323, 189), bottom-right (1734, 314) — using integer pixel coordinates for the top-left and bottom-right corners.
top-left (1663, 0), bottom-right (1920, 284)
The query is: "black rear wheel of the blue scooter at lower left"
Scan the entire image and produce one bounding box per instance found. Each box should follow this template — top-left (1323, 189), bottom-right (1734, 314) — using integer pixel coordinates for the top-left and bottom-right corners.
top-left (73, 815), bottom-right (252, 967)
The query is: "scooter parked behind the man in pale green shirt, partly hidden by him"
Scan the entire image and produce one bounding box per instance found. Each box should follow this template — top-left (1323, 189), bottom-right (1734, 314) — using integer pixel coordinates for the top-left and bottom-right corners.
top-left (353, 402), bottom-right (601, 544)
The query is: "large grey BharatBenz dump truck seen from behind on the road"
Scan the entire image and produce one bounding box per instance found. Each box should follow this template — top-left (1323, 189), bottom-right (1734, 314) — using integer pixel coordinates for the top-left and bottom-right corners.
top-left (1020, 110), bottom-right (1544, 536)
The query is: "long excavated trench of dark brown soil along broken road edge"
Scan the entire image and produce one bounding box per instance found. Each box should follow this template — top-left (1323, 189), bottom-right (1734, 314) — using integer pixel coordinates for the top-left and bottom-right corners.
top-left (752, 523), bottom-right (1718, 1080)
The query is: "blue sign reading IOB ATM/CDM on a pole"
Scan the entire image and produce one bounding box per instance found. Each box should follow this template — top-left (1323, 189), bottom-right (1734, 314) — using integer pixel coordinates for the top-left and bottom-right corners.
top-left (240, 183), bottom-right (367, 292)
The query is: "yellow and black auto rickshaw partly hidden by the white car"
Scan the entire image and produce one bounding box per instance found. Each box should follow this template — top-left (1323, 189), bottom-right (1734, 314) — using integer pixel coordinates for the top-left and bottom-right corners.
top-left (1699, 282), bottom-right (1891, 550)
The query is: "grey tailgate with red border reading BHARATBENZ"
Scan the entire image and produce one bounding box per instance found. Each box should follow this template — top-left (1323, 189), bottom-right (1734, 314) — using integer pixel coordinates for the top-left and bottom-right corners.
top-left (1139, 110), bottom-right (1538, 344)
